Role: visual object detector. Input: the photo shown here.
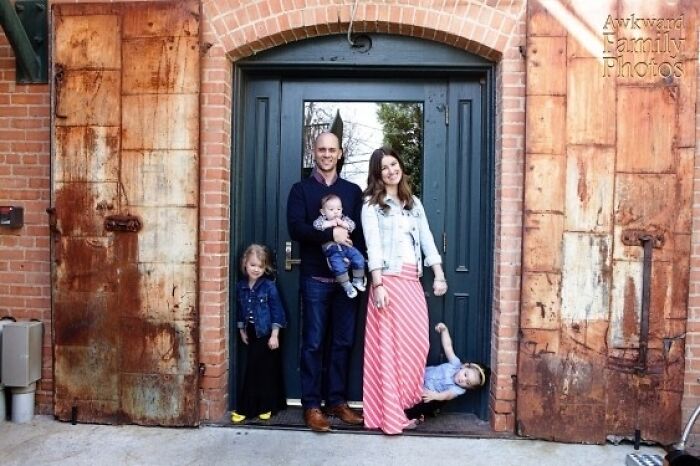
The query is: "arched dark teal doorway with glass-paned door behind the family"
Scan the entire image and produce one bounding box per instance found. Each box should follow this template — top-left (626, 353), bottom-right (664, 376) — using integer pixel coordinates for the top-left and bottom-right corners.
top-left (230, 36), bottom-right (493, 419)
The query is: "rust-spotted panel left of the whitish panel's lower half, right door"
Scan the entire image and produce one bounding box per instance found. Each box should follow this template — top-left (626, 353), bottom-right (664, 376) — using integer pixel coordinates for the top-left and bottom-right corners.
top-left (520, 272), bottom-right (561, 330)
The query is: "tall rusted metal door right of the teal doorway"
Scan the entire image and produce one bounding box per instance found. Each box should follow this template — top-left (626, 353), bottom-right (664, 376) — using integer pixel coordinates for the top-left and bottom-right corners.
top-left (517, 0), bottom-right (697, 444)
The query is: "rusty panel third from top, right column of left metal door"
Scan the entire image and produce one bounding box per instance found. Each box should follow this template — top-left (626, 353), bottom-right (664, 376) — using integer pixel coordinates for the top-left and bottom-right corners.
top-left (122, 94), bottom-right (199, 150)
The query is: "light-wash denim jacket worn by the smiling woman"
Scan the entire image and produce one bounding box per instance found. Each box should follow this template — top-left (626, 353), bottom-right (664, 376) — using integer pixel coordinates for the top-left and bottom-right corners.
top-left (362, 196), bottom-right (442, 277)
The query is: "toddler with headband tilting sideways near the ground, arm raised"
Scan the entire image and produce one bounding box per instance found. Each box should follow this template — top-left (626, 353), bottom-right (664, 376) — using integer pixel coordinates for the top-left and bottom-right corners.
top-left (406, 322), bottom-right (491, 420)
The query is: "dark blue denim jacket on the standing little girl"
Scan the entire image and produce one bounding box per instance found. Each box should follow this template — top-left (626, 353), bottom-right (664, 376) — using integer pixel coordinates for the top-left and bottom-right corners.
top-left (236, 277), bottom-right (287, 338)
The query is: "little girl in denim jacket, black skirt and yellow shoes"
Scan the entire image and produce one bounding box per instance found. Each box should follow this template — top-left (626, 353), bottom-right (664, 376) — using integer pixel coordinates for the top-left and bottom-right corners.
top-left (231, 244), bottom-right (287, 423)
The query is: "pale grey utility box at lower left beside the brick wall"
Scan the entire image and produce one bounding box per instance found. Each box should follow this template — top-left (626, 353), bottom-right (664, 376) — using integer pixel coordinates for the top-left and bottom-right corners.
top-left (0, 321), bottom-right (42, 387)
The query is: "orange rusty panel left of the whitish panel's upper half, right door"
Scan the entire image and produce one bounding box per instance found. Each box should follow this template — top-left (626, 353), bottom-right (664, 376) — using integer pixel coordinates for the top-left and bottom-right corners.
top-left (523, 213), bottom-right (564, 272)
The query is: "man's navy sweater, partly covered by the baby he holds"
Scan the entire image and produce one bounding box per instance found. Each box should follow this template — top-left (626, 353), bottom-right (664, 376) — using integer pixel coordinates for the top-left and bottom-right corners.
top-left (287, 175), bottom-right (366, 278)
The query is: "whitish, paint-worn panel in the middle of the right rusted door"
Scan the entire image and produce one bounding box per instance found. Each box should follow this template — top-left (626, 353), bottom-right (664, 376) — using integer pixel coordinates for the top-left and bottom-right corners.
top-left (561, 232), bottom-right (612, 323)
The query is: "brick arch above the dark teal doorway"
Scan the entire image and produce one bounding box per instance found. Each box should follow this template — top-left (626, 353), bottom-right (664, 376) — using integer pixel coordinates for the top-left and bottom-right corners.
top-left (203, 0), bottom-right (519, 61)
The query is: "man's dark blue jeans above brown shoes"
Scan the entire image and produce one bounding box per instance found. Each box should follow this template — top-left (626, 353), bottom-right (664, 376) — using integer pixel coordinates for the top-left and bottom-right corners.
top-left (300, 277), bottom-right (359, 409)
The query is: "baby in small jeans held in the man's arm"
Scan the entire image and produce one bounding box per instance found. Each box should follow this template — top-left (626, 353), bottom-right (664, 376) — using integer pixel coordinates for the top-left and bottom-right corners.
top-left (314, 194), bottom-right (366, 298)
